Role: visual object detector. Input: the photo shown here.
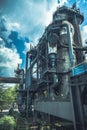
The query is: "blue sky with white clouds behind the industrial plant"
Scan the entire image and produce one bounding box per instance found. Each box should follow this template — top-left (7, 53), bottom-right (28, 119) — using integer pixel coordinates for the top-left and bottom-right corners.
top-left (0, 0), bottom-right (87, 76)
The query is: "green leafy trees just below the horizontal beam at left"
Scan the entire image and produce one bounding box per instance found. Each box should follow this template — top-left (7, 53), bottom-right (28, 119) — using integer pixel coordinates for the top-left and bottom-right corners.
top-left (0, 85), bottom-right (18, 112)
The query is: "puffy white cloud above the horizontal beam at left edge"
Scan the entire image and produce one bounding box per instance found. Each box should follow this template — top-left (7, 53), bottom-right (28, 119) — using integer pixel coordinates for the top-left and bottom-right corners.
top-left (0, 39), bottom-right (22, 76)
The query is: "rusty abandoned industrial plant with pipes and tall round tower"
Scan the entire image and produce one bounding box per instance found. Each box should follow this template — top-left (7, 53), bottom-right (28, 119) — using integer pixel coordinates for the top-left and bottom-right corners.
top-left (0, 4), bottom-right (87, 130)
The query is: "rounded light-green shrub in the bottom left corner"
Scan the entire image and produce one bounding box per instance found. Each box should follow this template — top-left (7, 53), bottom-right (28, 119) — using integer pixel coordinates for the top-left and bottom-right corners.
top-left (0, 116), bottom-right (16, 130)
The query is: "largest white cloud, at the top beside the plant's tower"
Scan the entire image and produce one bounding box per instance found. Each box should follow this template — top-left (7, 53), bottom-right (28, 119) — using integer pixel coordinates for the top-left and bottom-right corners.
top-left (2, 0), bottom-right (61, 40)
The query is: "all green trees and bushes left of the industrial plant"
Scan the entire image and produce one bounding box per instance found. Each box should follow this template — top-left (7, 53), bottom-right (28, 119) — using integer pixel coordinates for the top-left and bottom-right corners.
top-left (0, 85), bottom-right (32, 130)
